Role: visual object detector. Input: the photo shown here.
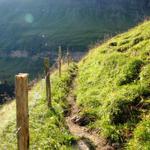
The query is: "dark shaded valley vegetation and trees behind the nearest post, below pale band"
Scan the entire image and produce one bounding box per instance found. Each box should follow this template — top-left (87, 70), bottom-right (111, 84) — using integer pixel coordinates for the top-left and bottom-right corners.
top-left (0, 57), bottom-right (43, 103)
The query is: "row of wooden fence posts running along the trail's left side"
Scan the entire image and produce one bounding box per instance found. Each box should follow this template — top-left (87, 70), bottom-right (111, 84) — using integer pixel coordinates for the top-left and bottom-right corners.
top-left (1, 47), bottom-right (71, 150)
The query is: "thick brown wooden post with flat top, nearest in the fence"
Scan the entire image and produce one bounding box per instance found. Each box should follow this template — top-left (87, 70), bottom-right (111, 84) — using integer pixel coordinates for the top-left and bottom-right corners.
top-left (15, 73), bottom-right (29, 150)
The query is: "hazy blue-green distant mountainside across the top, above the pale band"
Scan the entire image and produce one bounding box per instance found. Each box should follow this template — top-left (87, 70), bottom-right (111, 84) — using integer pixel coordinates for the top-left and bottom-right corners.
top-left (0, 0), bottom-right (150, 53)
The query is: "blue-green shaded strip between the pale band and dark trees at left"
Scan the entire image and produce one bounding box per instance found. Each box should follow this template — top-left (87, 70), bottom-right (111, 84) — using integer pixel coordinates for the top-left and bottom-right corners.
top-left (0, 58), bottom-right (43, 84)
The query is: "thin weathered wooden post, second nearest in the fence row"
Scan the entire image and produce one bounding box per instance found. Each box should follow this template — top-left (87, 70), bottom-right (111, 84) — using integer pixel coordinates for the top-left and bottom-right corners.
top-left (44, 58), bottom-right (51, 107)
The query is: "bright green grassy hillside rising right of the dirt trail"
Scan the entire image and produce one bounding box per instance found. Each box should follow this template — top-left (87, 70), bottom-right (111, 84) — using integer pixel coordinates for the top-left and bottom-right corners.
top-left (76, 21), bottom-right (150, 150)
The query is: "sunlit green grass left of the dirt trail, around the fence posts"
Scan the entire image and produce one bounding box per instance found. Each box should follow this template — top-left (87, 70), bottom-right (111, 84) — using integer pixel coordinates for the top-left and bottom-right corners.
top-left (0, 65), bottom-right (76, 150)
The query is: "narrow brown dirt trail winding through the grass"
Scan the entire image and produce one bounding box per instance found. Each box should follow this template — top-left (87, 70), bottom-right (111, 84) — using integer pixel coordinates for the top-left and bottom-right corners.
top-left (66, 82), bottom-right (113, 150)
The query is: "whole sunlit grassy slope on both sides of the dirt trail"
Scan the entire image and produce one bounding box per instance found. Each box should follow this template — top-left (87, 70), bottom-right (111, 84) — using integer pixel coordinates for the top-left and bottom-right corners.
top-left (0, 21), bottom-right (150, 150)
